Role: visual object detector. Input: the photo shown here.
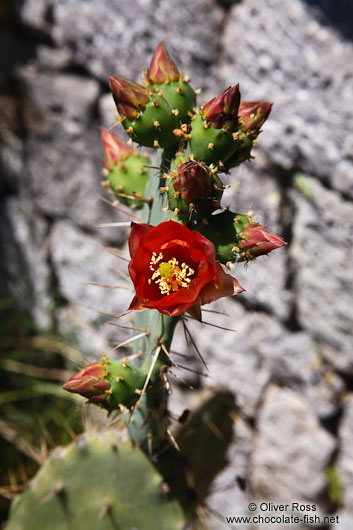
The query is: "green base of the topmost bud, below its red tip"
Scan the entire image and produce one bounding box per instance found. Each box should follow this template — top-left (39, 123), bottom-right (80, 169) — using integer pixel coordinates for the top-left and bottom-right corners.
top-left (154, 81), bottom-right (196, 123)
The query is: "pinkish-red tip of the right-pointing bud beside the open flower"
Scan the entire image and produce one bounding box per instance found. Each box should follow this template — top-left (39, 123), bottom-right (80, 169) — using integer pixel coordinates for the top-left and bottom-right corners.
top-left (238, 223), bottom-right (286, 259)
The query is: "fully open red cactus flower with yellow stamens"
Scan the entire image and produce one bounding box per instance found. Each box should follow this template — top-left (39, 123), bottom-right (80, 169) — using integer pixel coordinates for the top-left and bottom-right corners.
top-left (129, 221), bottom-right (244, 316)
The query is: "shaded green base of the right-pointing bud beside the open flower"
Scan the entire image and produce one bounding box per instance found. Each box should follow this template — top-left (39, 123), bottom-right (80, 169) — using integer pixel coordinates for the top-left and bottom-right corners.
top-left (196, 210), bottom-right (252, 264)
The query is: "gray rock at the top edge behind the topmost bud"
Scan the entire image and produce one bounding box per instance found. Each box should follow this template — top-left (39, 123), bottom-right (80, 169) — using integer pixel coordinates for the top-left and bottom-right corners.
top-left (53, 0), bottom-right (223, 89)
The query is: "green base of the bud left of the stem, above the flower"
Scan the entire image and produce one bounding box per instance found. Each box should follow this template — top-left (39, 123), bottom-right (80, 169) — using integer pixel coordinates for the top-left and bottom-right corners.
top-left (108, 154), bottom-right (150, 209)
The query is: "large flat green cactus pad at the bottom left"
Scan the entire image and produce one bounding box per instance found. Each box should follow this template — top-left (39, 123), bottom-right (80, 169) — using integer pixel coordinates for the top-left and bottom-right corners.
top-left (7, 431), bottom-right (185, 530)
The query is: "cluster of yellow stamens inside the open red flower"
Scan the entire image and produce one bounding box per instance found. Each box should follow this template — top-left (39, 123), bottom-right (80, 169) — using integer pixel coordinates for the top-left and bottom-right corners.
top-left (148, 252), bottom-right (195, 295)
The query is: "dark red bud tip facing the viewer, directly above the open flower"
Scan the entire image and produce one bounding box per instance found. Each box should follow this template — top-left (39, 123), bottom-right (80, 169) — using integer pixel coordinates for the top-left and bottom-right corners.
top-left (173, 161), bottom-right (212, 202)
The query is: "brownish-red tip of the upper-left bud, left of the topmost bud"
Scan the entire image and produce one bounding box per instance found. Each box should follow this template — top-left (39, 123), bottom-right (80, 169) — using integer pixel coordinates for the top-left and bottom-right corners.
top-left (109, 76), bottom-right (150, 120)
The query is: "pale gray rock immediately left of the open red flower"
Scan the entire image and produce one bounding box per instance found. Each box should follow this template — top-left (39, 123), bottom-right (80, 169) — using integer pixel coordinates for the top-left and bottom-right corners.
top-left (50, 221), bottom-right (133, 359)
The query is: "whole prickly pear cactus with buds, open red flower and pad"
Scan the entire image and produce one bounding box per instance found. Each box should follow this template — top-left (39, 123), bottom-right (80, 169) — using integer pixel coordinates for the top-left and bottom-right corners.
top-left (8, 43), bottom-right (284, 530)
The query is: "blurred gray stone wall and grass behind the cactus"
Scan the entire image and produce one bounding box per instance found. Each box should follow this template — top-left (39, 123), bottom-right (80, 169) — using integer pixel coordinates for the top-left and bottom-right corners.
top-left (0, 0), bottom-right (353, 530)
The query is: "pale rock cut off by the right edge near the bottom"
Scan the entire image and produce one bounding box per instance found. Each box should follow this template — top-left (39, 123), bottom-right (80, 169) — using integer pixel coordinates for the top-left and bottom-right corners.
top-left (337, 393), bottom-right (353, 519)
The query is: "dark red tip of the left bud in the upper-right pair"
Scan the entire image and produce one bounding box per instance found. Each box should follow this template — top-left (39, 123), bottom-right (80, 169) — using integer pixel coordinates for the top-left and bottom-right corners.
top-left (202, 85), bottom-right (240, 131)
